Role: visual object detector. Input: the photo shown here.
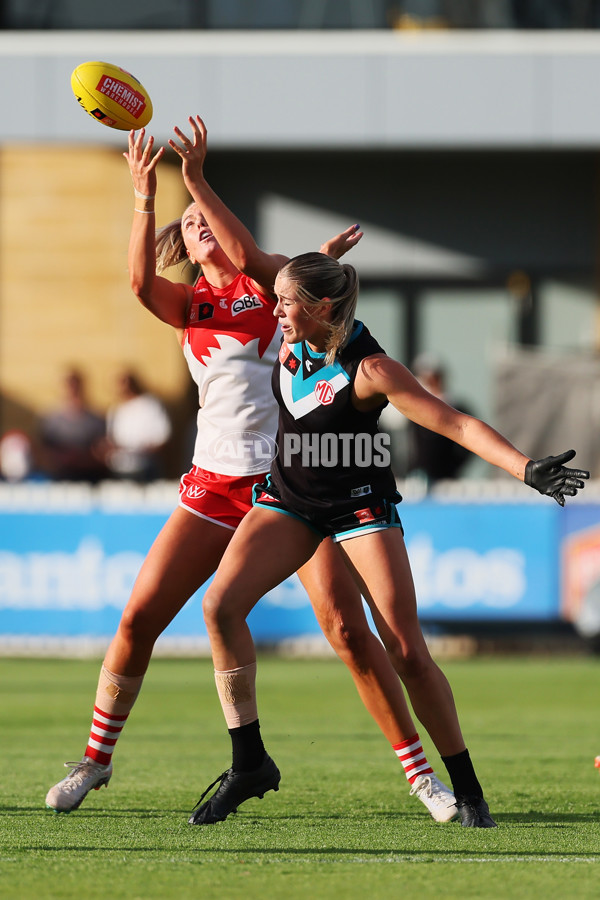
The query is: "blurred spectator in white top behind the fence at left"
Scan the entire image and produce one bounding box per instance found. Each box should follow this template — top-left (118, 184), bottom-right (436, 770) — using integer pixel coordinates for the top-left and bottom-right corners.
top-left (106, 371), bottom-right (172, 482)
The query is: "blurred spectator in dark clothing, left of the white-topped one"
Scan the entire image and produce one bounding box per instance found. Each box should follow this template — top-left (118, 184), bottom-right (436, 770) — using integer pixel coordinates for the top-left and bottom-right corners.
top-left (40, 369), bottom-right (107, 482)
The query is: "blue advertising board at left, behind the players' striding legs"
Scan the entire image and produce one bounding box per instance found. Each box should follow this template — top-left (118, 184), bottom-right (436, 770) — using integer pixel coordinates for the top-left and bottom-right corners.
top-left (0, 510), bottom-right (320, 642)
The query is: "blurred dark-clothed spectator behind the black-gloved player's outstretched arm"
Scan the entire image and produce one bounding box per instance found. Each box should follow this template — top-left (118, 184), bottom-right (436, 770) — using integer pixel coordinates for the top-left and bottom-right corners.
top-left (406, 353), bottom-right (473, 487)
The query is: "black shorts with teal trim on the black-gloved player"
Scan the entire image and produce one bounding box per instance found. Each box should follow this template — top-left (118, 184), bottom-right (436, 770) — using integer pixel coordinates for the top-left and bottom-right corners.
top-left (252, 475), bottom-right (404, 543)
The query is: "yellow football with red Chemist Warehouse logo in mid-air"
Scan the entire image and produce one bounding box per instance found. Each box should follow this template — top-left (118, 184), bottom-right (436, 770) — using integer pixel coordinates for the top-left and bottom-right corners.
top-left (71, 62), bottom-right (152, 131)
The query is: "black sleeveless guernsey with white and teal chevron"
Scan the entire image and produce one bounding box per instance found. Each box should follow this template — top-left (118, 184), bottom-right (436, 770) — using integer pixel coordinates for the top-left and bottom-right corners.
top-left (265, 322), bottom-right (401, 524)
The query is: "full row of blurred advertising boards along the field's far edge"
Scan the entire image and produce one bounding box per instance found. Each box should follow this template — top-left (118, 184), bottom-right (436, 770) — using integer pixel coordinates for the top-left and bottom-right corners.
top-left (0, 488), bottom-right (568, 643)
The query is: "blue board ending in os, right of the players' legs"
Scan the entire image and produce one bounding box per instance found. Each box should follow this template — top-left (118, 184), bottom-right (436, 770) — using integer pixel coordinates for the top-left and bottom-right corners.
top-left (400, 500), bottom-right (562, 621)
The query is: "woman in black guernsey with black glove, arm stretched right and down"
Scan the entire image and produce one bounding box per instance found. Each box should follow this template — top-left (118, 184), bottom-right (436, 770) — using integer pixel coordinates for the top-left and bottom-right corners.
top-left (195, 253), bottom-right (588, 828)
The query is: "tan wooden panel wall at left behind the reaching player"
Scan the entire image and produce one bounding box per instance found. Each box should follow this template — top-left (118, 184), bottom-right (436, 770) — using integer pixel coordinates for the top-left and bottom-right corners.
top-left (0, 144), bottom-right (189, 468)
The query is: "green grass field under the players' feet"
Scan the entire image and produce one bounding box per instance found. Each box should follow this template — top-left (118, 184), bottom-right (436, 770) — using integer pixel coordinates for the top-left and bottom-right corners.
top-left (0, 657), bottom-right (600, 900)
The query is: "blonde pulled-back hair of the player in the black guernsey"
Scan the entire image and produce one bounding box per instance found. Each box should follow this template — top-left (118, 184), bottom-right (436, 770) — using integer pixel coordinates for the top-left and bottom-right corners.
top-left (279, 253), bottom-right (358, 365)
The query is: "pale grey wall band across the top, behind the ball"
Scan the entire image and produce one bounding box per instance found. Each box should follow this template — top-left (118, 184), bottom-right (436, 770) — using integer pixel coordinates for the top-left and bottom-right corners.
top-left (0, 30), bottom-right (600, 150)
